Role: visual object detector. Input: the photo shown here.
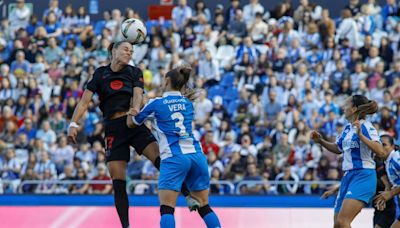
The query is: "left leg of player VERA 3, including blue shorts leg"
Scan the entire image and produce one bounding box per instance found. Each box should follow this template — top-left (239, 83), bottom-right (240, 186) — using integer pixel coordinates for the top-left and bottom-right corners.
top-left (158, 155), bottom-right (190, 228)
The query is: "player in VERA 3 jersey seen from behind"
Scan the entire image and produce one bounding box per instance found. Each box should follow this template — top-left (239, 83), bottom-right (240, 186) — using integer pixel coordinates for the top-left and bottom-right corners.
top-left (127, 67), bottom-right (221, 228)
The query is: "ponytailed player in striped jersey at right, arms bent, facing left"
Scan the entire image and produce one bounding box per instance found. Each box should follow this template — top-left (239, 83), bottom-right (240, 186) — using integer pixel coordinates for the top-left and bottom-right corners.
top-left (311, 95), bottom-right (384, 228)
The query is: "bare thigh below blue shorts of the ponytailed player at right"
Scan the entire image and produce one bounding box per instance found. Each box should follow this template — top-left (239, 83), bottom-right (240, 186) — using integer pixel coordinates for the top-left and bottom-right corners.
top-left (335, 199), bottom-right (365, 228)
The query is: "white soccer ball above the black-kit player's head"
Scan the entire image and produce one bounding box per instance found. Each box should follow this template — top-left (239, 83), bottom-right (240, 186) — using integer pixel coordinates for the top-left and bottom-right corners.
top-left (121, 18), bottom-right (147, 44)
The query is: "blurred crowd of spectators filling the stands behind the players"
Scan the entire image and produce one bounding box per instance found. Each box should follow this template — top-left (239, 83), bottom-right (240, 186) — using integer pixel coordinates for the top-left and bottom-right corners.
top-left (0, 0), bottom-right (400, 194)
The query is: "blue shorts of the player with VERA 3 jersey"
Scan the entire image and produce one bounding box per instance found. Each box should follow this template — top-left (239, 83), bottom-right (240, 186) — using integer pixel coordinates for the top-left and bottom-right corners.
top-left (158, 153), bottom-right (210, 192)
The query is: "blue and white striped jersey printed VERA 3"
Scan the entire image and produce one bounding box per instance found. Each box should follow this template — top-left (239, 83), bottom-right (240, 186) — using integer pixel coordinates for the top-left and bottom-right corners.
top-left (133, 91), bottom-right (202, 159)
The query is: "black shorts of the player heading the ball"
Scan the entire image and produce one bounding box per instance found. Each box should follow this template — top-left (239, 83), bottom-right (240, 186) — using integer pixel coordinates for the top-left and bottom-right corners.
top-left (104, 116), bottom-right (156, 162)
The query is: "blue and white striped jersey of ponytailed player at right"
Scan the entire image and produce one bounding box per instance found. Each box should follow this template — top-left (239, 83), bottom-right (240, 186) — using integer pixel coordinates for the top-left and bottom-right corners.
top-left (336, 120), bottom-right (380, 171)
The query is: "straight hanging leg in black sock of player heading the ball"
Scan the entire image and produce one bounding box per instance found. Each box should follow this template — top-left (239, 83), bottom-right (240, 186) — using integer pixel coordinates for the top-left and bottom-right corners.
top-left (107, 161), bottom-right (129, 227)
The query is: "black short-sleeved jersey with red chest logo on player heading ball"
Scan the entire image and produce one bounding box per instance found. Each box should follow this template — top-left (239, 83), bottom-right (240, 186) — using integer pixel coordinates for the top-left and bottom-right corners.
top-left (86, 65), bottom-right (143, 119)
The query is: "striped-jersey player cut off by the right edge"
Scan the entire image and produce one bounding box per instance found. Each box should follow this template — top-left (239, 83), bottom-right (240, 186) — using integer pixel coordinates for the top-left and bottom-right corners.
top-left (375, 135), bottom-right (400, 228)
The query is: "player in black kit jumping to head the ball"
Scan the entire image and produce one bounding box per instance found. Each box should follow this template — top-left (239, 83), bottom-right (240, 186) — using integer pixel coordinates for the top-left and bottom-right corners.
top-left (68, 41), bottom-right (200, 227)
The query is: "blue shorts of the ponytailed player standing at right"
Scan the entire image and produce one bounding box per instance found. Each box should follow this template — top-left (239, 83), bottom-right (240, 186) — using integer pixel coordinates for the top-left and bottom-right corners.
top-left (335, 169), bottom-right (377, 213)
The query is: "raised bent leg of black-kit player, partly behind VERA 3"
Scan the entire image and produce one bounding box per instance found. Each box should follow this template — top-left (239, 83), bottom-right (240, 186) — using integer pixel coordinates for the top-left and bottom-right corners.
top-left (132, 126), bottom-right (199, 211)
